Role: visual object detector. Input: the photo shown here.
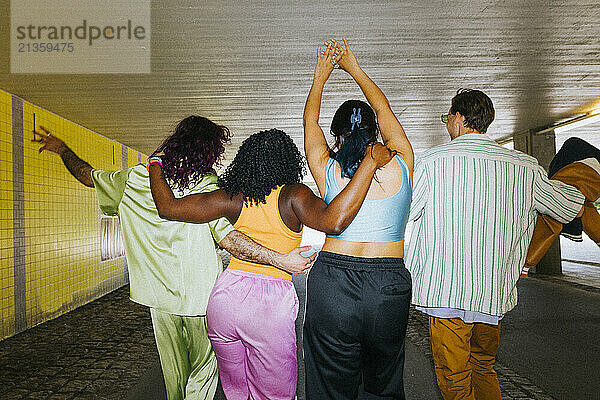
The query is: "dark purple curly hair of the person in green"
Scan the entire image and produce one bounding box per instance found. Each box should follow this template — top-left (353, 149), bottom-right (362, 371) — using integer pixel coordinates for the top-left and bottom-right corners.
top-left (156, 115), bottom-right (231, 192)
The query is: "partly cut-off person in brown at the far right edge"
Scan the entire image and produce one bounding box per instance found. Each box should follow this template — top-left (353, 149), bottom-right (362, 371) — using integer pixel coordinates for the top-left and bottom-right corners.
top-left (521, 137), bottom-right (600, 276)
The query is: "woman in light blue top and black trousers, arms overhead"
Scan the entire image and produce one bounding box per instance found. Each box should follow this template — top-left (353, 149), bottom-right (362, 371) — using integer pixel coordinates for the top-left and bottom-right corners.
top-left (303, 39), bottom-right (414, 400)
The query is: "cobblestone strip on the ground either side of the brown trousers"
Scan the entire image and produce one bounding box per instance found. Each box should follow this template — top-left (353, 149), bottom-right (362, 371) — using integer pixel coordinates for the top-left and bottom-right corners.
top-left (406, 307), bottom-right (554, 400)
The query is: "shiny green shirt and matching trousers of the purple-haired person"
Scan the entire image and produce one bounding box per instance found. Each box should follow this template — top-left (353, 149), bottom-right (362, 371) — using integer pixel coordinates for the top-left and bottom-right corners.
top-left (92, 164), bottom-right (233, 400)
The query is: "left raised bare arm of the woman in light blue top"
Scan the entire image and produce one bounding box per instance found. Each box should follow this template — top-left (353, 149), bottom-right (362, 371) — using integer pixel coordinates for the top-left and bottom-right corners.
top-left (302, 44), bottom-right (341, 194)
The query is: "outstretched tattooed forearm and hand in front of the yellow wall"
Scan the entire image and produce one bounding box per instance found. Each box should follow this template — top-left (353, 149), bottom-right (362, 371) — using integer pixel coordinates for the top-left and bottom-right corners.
top-left (32, 126), bottom-right (94, 187)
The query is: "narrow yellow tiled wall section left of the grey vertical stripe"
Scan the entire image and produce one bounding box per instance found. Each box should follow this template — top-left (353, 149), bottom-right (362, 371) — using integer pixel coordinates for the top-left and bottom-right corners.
top-left (0, 91), bottom-right (15, 338)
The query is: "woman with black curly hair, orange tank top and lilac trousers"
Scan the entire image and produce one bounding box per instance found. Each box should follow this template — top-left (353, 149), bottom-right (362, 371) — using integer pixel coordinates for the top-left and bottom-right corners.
top-left (149, 129), bottom-right (392, 400)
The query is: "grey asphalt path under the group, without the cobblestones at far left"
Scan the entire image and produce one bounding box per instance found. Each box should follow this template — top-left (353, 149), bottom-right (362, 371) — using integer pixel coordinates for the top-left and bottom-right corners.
top-left (130, 277), bottom-right (600, 400)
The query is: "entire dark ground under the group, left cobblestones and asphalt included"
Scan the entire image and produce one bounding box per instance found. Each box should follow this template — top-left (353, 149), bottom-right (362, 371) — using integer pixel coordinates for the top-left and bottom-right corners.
top-left (0, 277), bottom-right (600, 400)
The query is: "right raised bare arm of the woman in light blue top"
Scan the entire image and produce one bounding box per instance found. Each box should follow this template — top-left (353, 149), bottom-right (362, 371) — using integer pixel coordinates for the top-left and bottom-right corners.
top-left (332, 38), bottom-right (414, 173)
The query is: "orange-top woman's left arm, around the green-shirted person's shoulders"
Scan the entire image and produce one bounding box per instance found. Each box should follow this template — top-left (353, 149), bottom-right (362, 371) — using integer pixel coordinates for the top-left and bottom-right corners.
top-left (148, 162), bottom-right (239, 223)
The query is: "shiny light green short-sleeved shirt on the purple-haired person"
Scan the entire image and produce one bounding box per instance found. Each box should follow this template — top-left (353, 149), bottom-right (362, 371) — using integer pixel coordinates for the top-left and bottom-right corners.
top-left (92, 164), bottom-right (233, 316)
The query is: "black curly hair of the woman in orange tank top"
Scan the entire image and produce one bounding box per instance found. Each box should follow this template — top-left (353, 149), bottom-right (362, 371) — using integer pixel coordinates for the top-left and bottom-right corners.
top-left (219, 129), bottom-right (306, 205)
